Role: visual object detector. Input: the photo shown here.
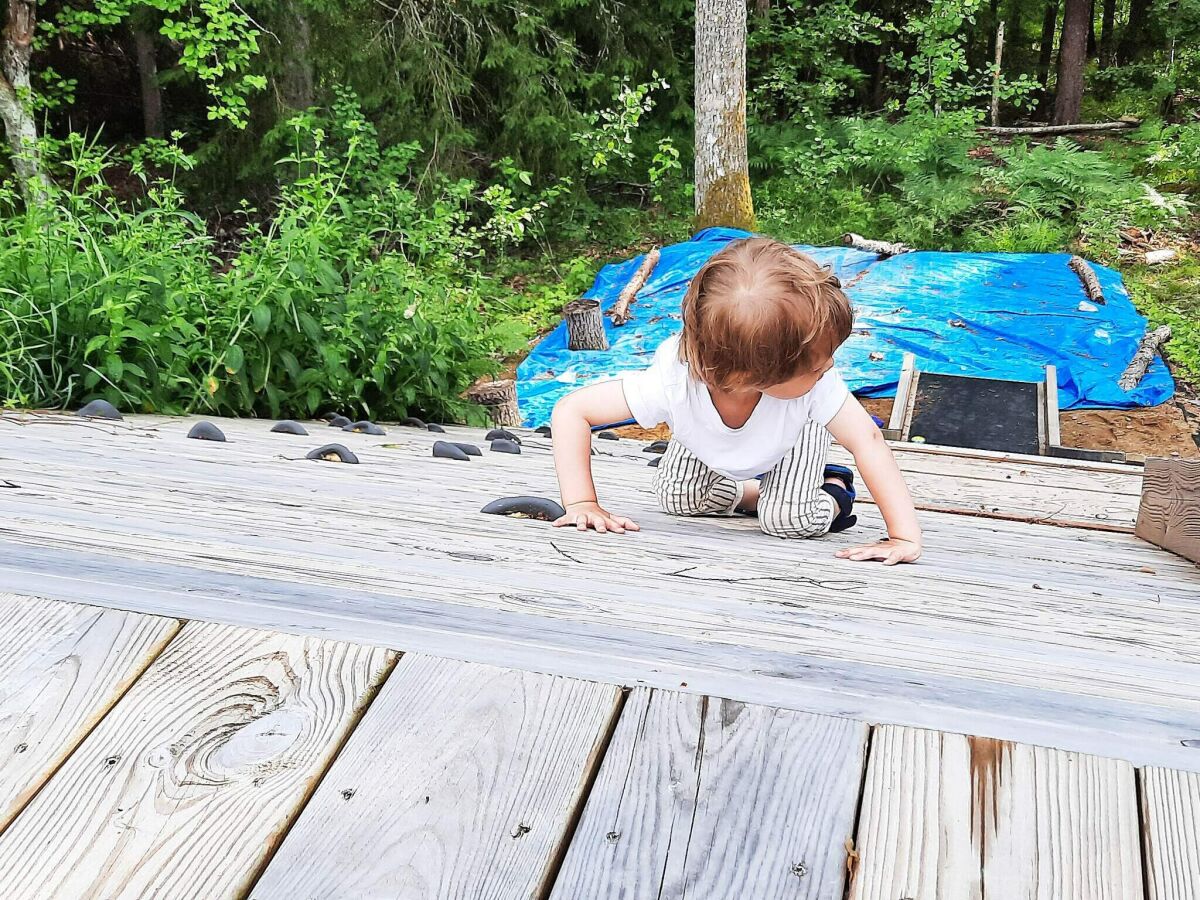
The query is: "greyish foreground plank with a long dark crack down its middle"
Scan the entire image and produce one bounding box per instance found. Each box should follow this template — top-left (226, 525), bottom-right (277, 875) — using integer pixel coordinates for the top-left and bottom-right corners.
top-left (552, 689), bottom-right (866, 900)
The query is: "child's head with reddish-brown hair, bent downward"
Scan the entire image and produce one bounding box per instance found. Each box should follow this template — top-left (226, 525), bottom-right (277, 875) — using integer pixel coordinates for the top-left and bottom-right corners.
top-left (679, 238), bottom-right (854, 400)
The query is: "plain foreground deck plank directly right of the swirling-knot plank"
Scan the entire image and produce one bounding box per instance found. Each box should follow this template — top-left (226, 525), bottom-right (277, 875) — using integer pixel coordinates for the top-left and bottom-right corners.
top-left (251, 655), bottom-right (619, 900)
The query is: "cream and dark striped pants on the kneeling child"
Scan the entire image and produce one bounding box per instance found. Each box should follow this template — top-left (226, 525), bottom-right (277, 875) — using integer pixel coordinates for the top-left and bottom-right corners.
top-left (654, 421), bottom-right (838, 538)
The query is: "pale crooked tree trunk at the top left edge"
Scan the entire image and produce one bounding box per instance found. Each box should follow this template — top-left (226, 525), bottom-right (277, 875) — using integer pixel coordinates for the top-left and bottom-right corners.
top-left (0, 0), bottom-right (49, 202)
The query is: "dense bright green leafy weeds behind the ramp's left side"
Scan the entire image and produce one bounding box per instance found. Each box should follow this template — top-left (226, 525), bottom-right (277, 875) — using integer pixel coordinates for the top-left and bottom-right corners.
top-left (0, 103), bottom-right (528, 418)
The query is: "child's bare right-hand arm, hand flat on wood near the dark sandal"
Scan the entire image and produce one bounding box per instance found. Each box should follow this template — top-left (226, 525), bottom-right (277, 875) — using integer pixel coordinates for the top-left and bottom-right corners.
top-left (829, 397), bottom-right (920, 565)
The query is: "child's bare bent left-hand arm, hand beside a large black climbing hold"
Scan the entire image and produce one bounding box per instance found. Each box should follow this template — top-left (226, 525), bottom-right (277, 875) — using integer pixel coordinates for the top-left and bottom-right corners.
top-left (551, 382), bottom-right (638, 534)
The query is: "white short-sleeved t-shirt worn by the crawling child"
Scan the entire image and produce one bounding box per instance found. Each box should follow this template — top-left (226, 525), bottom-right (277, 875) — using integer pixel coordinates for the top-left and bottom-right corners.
top-left (622, 336), bottom-right (850, 480)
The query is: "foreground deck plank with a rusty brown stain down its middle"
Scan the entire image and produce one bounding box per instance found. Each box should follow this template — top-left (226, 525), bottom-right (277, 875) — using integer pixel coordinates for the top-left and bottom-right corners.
top-left (850, 726), bottom-right (1142, 900)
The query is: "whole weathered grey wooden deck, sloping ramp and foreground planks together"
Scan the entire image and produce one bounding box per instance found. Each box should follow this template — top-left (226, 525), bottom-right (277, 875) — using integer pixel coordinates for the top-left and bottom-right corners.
top-left (0, 415), bottom-right (1200, 900)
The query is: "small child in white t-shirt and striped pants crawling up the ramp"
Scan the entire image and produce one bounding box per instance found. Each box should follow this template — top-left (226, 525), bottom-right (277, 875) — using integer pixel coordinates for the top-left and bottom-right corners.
top-left (552, 238), bottom-right (922, 565)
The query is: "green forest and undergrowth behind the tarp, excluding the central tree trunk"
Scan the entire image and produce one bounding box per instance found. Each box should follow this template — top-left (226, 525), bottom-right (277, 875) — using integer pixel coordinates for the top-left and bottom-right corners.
top-left (0, 0), bottom-right (1200, 420)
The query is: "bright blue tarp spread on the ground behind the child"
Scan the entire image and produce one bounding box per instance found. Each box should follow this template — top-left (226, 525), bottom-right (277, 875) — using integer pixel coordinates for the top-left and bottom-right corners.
top-left (517, 228), bottom-right (1175, 427)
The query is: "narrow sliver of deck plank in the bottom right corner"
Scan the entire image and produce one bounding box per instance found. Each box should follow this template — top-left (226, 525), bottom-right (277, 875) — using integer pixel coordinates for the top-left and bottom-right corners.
top-left (1141, 767), bottom-right (1200, 900)
